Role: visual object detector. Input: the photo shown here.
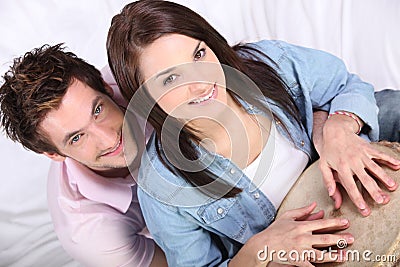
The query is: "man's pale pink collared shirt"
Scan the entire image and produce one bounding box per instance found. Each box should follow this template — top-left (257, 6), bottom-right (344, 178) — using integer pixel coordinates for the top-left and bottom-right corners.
top-left (47, 68), bottom-right (154, 267)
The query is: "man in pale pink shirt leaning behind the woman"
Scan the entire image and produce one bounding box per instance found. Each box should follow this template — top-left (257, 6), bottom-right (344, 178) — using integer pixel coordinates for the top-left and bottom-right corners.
top-left (0, 44), bottom-right (167, 267)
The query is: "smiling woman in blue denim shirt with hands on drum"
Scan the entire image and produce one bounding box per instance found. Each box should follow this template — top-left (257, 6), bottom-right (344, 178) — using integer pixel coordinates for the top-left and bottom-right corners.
top-left (107, 1), bottom-right (399, 266)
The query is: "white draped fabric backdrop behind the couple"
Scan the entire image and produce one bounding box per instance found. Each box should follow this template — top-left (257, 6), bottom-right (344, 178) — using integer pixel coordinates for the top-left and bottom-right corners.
top-left (0, 0), bottom-right (400, 267)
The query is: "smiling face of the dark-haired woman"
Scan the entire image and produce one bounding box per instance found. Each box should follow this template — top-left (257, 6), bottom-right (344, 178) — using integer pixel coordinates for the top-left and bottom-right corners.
top-left (139, 34), bottom-right (227, 120)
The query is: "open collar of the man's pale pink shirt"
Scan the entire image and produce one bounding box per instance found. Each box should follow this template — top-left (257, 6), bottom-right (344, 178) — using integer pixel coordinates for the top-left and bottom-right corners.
top-left (65, 158), bottom-right (136, 213)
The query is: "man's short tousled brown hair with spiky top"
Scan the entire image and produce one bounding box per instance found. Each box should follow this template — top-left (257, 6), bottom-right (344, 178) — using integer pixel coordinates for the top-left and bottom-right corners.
top-left (0, 44), bottom-right (107, 155)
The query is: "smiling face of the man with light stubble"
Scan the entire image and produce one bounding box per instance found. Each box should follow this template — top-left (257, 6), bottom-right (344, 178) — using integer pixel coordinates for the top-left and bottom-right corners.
top-left (40, 80), bottom-right (138, 171)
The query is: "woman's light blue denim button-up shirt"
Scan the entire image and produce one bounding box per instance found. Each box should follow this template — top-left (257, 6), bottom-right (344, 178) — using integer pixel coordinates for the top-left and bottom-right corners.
top-left (138, 41), bottom-right (378, 267)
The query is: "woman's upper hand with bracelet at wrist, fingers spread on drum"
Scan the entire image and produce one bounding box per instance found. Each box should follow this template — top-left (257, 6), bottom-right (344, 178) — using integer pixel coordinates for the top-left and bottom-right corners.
top-left (313, 112), bottom-right (400, 216)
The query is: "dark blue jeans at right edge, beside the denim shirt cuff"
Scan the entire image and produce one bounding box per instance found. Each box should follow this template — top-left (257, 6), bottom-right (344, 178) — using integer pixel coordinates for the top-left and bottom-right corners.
top-left (375, 89), bottom-right (400, 142)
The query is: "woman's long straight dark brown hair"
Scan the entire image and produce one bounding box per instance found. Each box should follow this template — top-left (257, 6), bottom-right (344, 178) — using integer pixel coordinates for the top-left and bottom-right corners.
top-left (107, 0), bottom-right (300, 197)
